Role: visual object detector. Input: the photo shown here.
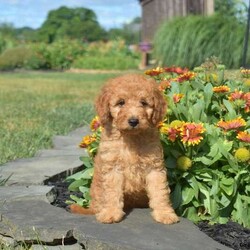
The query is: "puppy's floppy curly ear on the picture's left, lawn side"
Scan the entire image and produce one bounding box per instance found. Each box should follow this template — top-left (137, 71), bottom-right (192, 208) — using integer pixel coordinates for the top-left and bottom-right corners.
top-left (95, 87), bottom-right (112, 126)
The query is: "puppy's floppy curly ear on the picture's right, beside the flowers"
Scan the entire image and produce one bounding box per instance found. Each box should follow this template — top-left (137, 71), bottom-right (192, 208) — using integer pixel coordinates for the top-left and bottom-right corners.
top-left (152, 88), bottom-right (167, 126)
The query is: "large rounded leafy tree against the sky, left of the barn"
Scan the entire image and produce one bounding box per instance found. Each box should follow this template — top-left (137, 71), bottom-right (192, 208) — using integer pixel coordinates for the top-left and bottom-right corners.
top-left (39, 7), bottom-right (105, 42)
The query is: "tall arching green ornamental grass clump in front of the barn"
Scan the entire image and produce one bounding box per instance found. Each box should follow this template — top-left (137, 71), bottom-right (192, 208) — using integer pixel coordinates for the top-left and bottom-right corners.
top-left (154, 15), bottom-right (250, 68)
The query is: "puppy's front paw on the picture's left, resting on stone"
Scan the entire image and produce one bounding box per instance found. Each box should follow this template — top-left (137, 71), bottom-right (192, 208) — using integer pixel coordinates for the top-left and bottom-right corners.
top-left (96, 209), bottom-right (125, 223)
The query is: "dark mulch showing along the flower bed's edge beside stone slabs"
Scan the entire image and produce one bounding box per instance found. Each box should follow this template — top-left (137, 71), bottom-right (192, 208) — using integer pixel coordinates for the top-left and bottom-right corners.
top-left (47, 180), bottom-right (250, 250)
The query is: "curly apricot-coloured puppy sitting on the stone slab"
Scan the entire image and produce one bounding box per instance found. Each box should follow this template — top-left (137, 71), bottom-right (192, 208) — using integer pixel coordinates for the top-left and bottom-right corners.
top-left (71, 74), bottom-right (179, 224)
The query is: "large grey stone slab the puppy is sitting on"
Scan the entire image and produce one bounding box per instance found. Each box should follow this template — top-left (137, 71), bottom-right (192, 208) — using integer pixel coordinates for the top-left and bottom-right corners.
top-left (0, 200), bottom-right (229, 250)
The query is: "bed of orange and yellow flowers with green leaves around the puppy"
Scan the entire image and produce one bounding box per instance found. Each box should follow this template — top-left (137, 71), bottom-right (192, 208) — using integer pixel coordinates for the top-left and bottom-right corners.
top-left (69, 58), bottom-right (250, 227)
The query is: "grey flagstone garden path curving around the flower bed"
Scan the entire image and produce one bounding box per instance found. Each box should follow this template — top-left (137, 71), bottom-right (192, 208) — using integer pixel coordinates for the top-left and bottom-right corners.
top-left (0, 127), bottom-right (230, 250)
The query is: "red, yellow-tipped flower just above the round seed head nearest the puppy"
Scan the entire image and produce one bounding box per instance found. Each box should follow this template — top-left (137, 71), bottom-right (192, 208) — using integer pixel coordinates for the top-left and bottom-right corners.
top-left (181, 122), bottom-right (205, 146)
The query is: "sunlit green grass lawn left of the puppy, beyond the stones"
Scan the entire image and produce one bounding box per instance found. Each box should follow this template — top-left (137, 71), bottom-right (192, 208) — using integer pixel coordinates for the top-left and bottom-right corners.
top-left (0, 72), bottom-right (119, 164)
